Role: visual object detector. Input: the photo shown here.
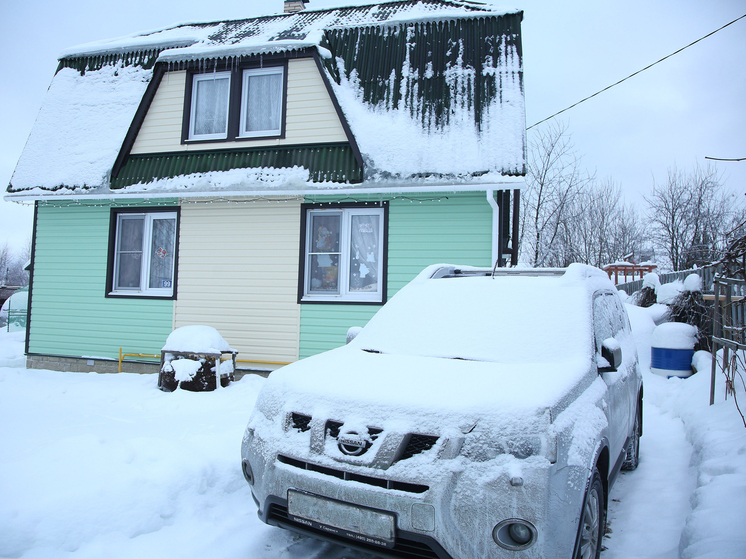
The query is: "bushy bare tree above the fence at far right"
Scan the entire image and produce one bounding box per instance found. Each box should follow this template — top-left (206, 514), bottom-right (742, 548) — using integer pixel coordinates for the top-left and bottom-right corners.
top-left (645, 165), bottom-right (743, 271)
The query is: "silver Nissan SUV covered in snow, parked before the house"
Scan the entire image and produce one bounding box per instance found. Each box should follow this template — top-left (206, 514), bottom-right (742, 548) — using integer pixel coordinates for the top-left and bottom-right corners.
top-left (241, 264), bottom-right (642, 559)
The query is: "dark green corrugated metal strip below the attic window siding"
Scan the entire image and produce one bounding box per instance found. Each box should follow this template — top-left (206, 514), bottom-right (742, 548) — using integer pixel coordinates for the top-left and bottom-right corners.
top-left (111, 144), bottom-right (363, 189)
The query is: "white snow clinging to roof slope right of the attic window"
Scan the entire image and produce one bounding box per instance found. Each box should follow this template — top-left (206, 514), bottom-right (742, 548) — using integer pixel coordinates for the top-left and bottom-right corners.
top-left (330, 30), bottom-right (526, 179)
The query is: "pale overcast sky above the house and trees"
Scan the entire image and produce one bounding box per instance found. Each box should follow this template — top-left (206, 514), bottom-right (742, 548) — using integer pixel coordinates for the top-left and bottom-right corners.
top-left (0, 0), bottom-right (746, 254)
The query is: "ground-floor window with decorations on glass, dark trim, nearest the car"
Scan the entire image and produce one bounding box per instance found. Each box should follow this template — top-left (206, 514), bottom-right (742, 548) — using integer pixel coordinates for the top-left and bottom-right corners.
top-left (299, 204), bottom-right (387, 303)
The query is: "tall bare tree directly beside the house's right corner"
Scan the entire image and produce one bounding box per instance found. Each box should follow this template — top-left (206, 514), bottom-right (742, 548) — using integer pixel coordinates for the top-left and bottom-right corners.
top-left (520, 123), bottom-right (592, 266)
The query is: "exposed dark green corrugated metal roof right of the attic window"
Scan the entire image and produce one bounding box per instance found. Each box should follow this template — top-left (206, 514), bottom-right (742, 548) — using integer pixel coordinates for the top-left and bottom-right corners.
top-left (321, 12), bottom-right (523, 136)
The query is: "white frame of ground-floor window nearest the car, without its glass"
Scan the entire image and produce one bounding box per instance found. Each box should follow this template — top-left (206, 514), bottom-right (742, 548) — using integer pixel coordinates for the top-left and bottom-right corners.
top-left (301, 207), bottom-right (386, 303)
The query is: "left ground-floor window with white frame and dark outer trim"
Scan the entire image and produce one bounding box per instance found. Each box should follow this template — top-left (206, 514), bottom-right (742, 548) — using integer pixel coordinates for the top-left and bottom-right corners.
top-left (107, 208), bottom-right (178, 297)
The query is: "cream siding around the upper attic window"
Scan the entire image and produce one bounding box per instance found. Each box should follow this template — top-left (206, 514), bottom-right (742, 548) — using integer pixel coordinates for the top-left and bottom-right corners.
top-left (131, 58), bottom-right (347, 154)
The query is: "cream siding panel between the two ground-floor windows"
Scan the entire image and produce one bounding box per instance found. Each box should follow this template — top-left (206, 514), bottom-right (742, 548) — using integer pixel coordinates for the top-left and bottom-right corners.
top-left (174, 201), bottom-right (300, 362)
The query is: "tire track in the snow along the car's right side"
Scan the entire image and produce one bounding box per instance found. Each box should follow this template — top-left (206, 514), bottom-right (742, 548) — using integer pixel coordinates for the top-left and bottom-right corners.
top-left (601, 399), bottom-right (696, 559)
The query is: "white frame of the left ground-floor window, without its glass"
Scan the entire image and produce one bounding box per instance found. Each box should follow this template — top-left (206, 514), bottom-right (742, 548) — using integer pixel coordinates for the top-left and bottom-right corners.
top-left (110, 212), bottom-right (178, 297)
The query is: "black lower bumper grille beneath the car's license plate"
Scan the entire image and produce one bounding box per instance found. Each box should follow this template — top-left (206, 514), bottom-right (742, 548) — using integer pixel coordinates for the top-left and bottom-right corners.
top-left (267, 504), bottom-right (450, 559)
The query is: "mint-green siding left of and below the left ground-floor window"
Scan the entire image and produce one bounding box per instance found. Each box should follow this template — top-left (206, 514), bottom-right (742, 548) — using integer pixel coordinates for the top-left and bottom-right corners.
top-left (29, 203), bottom-right (173, 364)
